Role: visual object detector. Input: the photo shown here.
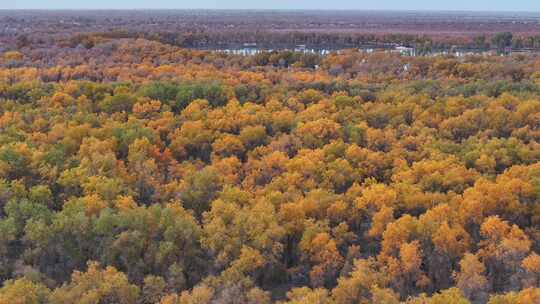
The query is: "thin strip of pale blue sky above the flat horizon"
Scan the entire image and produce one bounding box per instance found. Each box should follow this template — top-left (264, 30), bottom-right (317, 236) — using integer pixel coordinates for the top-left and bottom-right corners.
top-left (0, 0), bottom-right (540, 12)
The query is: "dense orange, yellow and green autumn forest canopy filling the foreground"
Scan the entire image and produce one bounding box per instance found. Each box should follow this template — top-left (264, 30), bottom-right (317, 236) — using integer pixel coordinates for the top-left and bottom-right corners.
top-left (0, 9), bottom-right (540, 304)
